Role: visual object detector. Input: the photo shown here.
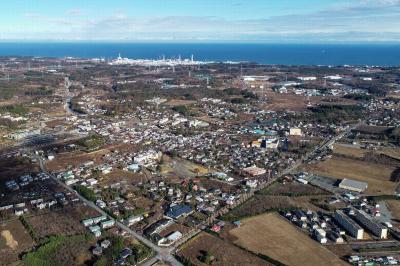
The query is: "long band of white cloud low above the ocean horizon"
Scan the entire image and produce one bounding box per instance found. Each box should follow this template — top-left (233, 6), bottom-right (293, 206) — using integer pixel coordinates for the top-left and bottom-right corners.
top-left (7, 0), bottom-right (400, 42)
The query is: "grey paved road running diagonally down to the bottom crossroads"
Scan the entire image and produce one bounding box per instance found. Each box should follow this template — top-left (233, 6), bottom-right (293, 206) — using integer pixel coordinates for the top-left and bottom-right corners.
top-left (38, 157), bottom-right (182, 266)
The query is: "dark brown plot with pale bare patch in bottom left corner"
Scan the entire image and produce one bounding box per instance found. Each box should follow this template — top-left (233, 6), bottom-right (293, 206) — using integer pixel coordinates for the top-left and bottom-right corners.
top-left (0, 220), bottom-right (34, 265)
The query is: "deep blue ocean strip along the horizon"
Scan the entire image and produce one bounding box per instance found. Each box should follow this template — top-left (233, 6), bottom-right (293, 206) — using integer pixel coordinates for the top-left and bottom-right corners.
top-left (0, 42), bottom-right (400, 66)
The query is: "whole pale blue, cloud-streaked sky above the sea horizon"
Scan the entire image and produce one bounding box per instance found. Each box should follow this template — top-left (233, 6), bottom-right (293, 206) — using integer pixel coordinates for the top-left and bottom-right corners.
top-left (0, 0), bottom-right (400, 43)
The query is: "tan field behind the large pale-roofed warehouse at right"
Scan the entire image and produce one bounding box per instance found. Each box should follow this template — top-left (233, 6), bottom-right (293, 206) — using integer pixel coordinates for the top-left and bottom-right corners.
top-left (305, 156), bottom-right (398, 194)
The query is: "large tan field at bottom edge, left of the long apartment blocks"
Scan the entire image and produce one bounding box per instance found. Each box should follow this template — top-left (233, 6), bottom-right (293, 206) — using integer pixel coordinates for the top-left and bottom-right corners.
top-left (230, 213), bottom-right (346, 265)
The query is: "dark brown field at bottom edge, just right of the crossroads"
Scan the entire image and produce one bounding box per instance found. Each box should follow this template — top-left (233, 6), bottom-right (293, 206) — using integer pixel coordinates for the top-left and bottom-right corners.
top-left (177, 233), bottom-right (271, 266)
